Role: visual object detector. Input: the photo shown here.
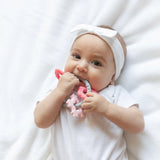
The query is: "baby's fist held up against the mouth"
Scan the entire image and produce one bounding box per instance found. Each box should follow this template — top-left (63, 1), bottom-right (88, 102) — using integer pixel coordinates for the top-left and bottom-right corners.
top-left (57, 72), bottom-right (80, 96)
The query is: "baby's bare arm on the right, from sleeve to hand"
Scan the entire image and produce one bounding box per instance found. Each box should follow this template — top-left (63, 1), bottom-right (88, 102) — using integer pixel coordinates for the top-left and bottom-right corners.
top-left (81, 93), bottom-right (144, 133)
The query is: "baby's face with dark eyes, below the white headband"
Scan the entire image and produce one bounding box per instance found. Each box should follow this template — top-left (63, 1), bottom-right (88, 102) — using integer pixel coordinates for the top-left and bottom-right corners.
top-left (64, 34), bottom-right (115, 91)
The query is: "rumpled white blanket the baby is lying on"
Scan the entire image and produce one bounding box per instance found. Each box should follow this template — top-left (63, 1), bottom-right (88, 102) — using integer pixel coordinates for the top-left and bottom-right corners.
top-left (0, 0), bottom-right (160, 160)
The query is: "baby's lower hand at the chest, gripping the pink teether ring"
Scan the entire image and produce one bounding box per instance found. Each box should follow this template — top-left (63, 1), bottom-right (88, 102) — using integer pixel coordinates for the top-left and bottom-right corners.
top-left (81, 92), bottom-right (110, 115)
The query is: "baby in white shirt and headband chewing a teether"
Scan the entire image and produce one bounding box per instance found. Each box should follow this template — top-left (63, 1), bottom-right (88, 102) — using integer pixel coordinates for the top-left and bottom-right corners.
top-left (34, 24), bottom-right (144, 160)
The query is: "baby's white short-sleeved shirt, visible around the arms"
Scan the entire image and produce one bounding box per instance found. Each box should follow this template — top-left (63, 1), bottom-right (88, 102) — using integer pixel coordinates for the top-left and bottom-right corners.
top-left (52, 86), bottom-right (136, 160)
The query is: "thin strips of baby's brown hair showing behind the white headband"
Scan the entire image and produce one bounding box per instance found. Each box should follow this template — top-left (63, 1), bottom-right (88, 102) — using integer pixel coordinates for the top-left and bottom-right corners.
top-left (98, 25), bottom-right (127, 58)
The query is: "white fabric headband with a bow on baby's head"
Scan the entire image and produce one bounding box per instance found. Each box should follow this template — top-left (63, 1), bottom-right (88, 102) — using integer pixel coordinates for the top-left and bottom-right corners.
top-left (71, 24), bottom-right (125, 80)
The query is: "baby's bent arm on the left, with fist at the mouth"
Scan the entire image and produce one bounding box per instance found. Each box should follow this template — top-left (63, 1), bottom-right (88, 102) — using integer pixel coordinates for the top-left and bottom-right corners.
top-left (34, 72), bottom-right (79, 128)
